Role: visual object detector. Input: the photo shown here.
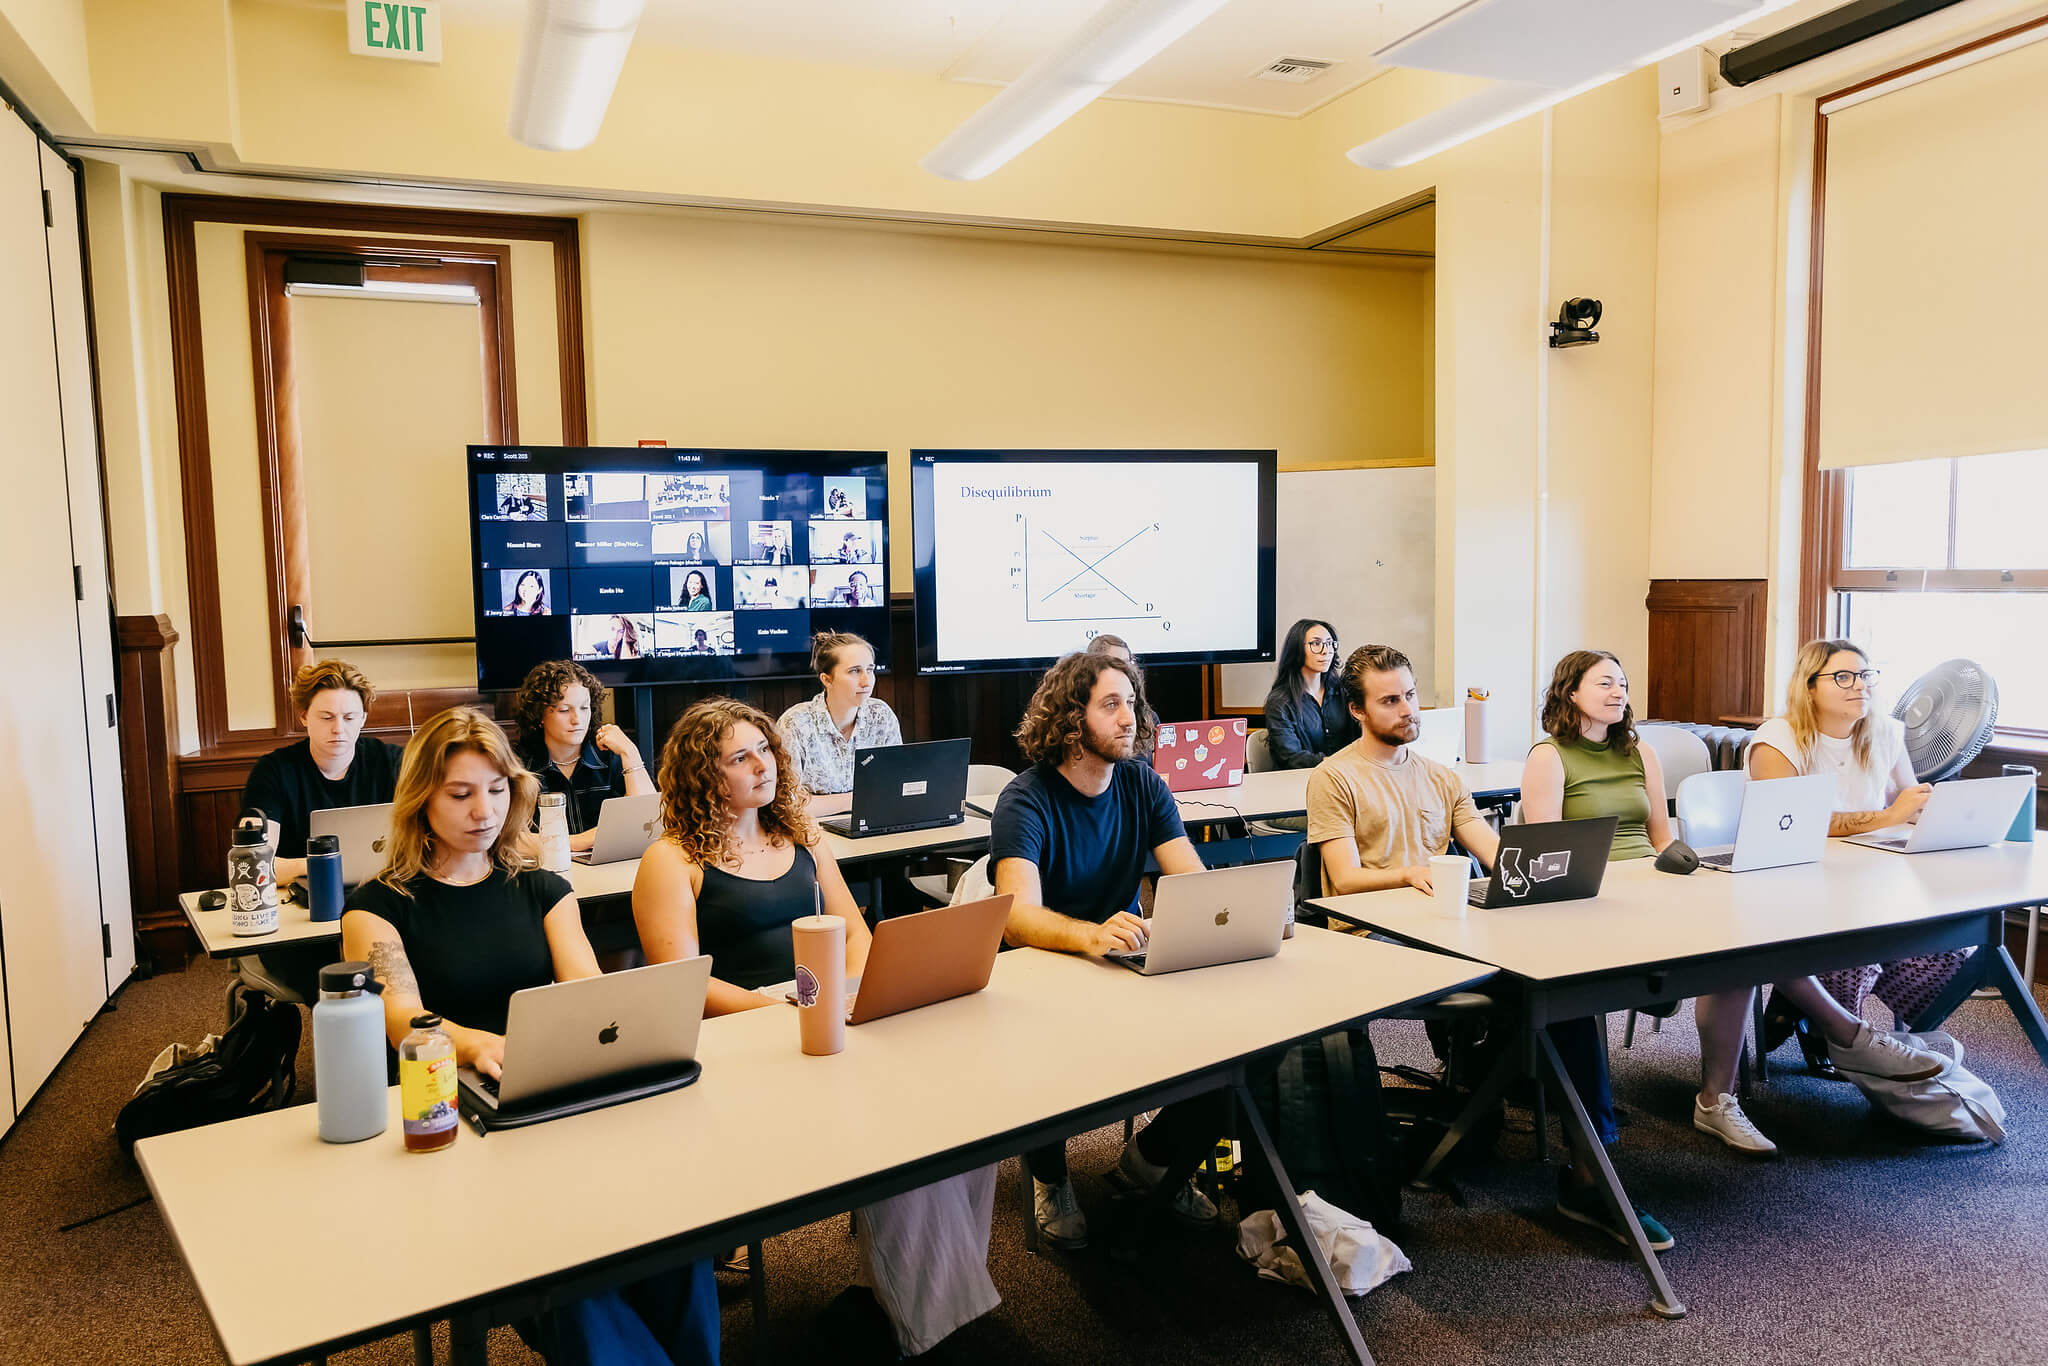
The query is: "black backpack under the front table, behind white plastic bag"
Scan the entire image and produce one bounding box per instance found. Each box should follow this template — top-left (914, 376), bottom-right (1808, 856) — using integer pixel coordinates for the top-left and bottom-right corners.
top-left (1247, 1030), bottom-right (1403, 1233)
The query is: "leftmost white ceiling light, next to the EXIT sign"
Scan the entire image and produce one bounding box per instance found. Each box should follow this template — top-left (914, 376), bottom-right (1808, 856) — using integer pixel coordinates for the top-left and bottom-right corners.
top-left (510, 0), bottom-right (645, 152)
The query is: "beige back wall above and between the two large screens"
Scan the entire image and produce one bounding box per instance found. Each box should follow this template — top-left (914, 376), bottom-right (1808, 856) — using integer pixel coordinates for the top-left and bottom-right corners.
top-left (584, 213), bottom-right (1425, 590)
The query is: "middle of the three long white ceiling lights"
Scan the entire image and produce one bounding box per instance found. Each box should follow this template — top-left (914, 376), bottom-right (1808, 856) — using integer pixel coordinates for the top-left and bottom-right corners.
top-left (918, 0), bottom-right (1229, 180)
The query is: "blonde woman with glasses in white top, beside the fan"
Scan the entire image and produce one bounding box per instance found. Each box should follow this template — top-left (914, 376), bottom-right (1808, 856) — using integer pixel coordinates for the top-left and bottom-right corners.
top-left (1743, 641), bottom-right (1970, 1026)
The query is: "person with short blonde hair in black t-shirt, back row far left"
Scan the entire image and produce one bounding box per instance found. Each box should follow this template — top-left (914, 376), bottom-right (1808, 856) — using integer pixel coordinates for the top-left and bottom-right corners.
top-left (242, 659), bottom-right (399, 883)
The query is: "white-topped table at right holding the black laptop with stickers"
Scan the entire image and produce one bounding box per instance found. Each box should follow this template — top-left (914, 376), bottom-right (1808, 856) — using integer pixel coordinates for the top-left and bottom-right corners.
top-left (1311, 840), bottom-right (2048, 1317)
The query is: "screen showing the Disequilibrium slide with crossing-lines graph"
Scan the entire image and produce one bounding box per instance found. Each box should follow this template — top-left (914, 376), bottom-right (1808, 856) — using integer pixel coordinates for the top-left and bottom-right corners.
top-left (911, 451), bottom-right (1278, 674)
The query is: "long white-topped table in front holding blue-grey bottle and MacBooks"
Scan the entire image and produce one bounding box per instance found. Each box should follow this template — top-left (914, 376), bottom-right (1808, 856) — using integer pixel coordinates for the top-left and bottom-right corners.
top-left (135, 926), bottom-right (1491, 1366)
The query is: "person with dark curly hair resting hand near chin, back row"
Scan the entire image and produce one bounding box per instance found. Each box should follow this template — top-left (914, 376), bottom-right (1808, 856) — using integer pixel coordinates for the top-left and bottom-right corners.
top-left (512, 659), bottom-right (653, 850)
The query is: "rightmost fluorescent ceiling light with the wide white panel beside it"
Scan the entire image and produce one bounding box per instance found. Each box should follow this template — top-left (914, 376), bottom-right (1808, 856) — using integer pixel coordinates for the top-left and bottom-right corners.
top-left (1346, 0), bottom-right (1788, 170)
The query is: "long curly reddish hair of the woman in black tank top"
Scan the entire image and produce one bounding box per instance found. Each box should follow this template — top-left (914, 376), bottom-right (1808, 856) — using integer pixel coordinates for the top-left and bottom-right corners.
top-left (659, 696), bottom-right (817, 868)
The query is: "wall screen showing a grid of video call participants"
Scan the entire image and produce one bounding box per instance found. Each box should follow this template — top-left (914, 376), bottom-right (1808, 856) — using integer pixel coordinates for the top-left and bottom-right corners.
top-left (469, 446), bottom-right (889, 690)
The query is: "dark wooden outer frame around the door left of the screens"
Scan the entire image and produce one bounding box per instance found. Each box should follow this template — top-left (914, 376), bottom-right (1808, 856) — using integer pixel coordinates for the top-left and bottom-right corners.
top-left (164, 195), bottom-right (588, 754)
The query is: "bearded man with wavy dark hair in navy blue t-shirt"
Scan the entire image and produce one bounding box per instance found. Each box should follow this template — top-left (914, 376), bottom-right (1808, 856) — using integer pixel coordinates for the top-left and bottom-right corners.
top-left (989, 653), bottom-right (1223, 1249)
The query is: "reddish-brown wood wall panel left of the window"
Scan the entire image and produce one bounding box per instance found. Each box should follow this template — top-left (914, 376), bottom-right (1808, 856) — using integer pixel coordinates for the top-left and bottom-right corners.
top-left (1640, 580), bottom-right (1765, 725)
